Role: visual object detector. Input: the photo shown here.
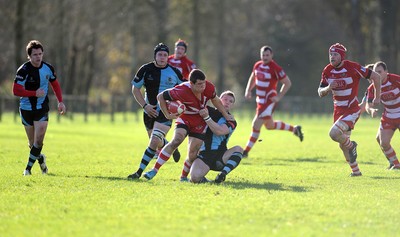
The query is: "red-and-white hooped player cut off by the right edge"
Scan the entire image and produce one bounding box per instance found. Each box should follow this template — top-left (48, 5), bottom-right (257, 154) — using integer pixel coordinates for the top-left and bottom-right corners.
top-left (366, 61), bottom-right (400, 170)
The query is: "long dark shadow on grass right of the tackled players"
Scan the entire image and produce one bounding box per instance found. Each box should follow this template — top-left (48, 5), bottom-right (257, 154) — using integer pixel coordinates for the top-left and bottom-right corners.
top-left (224, 181), bottom-right (310, 193)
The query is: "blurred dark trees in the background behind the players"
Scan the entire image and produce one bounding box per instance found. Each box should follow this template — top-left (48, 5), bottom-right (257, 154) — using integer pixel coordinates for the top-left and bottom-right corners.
top-left (0, 0), bottom-right (400, 109)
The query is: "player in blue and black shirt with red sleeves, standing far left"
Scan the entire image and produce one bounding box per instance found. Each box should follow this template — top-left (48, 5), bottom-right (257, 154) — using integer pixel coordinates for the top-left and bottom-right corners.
top-left (13, 40), bottom-right (66, 176)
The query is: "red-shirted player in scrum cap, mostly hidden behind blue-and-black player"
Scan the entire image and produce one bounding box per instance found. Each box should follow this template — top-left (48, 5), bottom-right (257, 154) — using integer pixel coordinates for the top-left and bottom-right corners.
top-left (168, 39), bottom-right (196, 79)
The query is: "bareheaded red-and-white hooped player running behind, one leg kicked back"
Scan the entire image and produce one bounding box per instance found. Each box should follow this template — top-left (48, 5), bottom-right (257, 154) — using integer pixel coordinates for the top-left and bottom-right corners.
top-left (243, 46), bottom-right (303, 157)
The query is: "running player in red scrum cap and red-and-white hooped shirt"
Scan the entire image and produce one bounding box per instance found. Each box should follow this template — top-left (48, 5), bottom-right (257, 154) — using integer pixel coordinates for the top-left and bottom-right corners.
top-left (318, 43), bottom-right (381, 177)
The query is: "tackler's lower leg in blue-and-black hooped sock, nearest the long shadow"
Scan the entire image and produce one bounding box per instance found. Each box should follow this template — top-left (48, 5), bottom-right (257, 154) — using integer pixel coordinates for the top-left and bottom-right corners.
top-left (215, 146), bottom-right (243, 183)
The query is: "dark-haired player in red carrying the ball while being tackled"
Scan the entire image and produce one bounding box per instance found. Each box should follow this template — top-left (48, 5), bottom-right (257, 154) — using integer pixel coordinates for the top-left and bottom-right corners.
top-left (144, 69), bottom-right (232, 181)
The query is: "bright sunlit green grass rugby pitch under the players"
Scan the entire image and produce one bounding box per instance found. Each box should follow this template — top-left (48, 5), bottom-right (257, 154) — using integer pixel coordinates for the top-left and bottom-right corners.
top-left (0, 111), bottom-right (400, 237)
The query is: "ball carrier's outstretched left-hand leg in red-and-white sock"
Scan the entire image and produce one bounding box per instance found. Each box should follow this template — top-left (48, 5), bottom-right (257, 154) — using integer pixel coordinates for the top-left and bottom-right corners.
top-left (144, 127), bottom-right (187, 180)
